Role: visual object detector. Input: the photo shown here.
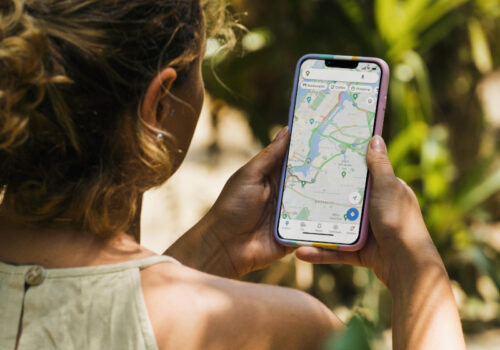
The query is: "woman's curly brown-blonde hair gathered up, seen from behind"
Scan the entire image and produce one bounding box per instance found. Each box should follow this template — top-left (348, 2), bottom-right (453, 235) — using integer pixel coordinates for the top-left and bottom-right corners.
top-left (0, 0), bottom-right (233, 235)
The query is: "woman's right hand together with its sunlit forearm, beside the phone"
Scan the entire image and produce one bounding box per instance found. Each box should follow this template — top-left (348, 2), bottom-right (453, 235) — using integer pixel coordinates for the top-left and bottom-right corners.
top-left (296, 136), bottom-right (465, 350)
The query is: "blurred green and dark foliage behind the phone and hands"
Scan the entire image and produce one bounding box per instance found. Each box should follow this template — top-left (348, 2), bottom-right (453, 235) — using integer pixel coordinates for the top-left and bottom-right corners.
top-left (200, 0), bottom-right (500, 349)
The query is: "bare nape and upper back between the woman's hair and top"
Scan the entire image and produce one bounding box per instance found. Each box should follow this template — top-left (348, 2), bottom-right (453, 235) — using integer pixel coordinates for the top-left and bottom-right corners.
top-left (0, 217), bottom-right (154, 268)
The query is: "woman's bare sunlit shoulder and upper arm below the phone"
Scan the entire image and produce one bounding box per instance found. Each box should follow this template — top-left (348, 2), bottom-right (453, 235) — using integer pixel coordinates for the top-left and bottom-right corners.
top-left (141, 263), bottom-right (340, 350)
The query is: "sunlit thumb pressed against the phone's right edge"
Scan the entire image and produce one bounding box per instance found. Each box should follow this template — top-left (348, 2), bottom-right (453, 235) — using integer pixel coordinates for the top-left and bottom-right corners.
top-left (366, 135), bottom-right (395, 184)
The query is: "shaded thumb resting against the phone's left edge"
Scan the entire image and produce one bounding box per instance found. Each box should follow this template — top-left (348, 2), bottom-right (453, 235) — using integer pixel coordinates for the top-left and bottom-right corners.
top-left (247, 127), bottom-right (290, 175)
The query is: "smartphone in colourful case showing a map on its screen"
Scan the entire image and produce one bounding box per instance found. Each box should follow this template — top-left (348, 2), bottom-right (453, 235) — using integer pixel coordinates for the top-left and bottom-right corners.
top-left (275, 54), bottom-right (389, 251)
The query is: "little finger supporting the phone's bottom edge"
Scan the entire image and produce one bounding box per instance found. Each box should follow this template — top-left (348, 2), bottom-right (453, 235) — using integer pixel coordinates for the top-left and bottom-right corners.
top-left (295, 247), bottom-right (363, 266)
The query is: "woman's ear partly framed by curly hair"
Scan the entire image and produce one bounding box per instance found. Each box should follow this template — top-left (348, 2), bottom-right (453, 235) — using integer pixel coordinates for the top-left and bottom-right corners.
top-left (141, 67), bottom-right (177, 126)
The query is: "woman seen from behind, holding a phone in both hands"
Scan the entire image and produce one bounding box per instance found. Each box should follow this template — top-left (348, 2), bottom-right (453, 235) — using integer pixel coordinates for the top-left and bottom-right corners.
top-left (0, 0), bottom-right (464, 350)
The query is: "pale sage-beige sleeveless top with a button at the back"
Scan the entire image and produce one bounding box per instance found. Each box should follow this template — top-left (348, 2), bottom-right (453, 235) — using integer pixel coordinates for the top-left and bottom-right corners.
top-left (0, 256), bottom-right (179, 350)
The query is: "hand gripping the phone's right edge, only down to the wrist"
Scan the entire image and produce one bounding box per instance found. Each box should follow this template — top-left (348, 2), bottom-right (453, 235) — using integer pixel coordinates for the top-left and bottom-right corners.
top-left (296, 136), bottom-right (441, 288)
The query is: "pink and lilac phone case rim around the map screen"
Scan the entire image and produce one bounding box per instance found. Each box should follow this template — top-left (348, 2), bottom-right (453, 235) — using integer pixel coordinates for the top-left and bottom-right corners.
top-left (274, 54), bottom-right (389, 251)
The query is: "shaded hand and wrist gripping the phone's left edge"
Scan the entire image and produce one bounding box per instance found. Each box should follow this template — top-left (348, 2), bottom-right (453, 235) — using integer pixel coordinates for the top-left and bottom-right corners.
top-left (165, 128), bottom-right (293, 277)
